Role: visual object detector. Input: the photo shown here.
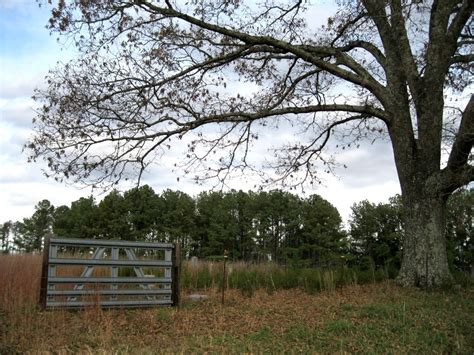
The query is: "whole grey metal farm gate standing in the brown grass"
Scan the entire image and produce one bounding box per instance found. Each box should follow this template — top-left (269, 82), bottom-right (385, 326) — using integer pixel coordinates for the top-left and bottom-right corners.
top-left (40, 238), bottom-right (180, 308)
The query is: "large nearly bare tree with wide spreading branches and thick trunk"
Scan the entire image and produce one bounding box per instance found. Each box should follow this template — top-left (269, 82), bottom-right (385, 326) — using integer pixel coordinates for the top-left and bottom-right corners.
top-left (26, 0), bottom-right (474, 286)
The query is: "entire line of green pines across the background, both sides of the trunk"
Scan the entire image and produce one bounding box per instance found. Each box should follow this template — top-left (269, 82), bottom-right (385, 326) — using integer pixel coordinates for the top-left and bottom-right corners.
top-left (1, 185), bottom-right (474, 273)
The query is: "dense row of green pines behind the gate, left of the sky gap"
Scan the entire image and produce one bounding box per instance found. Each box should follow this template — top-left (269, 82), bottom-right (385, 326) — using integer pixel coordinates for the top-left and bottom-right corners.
top-left (11, 185), bottom-right (345, 266)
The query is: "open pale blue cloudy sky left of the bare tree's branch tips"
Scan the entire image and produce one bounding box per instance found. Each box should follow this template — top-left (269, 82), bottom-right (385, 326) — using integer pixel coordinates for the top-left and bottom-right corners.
top-left (0, 0), bottom-right (86, 223)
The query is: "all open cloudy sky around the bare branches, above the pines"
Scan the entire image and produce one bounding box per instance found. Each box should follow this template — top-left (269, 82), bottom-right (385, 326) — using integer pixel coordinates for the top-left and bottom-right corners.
top-left (0, 0), bottom-right (400, 223)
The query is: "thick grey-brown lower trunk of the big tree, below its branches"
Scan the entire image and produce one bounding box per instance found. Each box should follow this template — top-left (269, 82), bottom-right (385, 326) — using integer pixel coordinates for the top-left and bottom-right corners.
top-left (397, 193), bottom-right (452, 288)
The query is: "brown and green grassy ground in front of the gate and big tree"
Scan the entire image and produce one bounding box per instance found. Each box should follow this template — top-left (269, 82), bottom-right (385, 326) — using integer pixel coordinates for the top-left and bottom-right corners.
top-left (0, 255), bottom-right (474, 354)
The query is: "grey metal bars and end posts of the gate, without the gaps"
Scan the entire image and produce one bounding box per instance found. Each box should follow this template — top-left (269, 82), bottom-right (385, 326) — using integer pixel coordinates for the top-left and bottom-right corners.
top-left (39, 235), bottom-right (181, 310)
